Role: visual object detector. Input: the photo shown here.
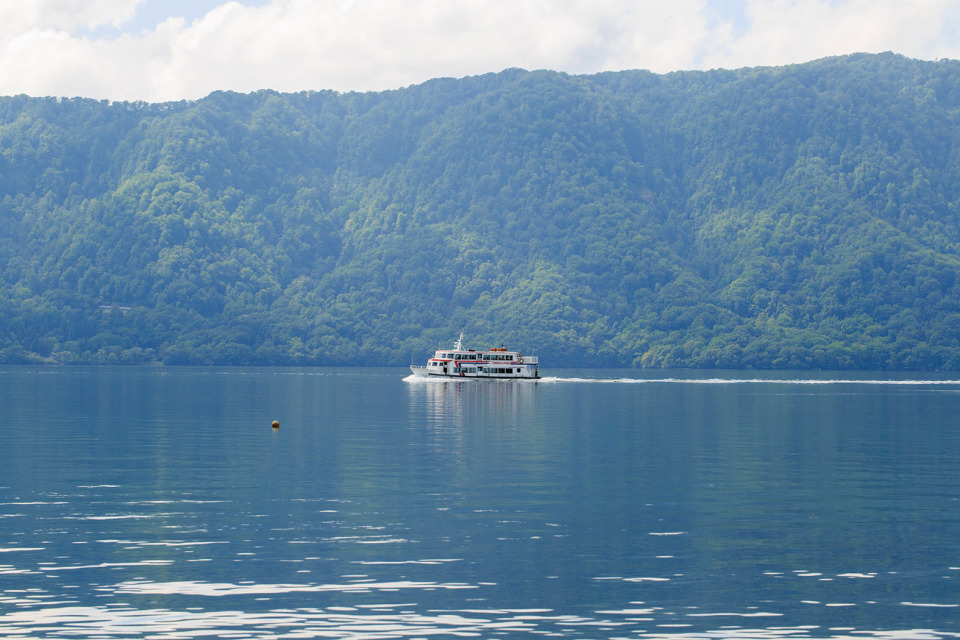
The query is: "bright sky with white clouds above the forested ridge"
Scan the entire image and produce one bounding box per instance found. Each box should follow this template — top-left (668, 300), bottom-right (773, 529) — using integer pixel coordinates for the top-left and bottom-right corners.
top-left (0, 0), bottom-right (960, 102)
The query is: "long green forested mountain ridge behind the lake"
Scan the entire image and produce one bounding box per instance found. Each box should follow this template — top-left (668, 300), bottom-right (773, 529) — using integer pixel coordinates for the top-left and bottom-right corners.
top-left (0, 54), bottom-right (960, 370)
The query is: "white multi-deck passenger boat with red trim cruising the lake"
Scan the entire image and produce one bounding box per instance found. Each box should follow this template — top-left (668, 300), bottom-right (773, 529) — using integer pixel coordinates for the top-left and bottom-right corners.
top-left (410, 332), bottom-right (540, 380)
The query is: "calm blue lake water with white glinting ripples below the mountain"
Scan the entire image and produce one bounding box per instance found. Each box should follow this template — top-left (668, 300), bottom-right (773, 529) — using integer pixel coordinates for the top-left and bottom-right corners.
top-left (0, 367), bottom-right (960, 640)
